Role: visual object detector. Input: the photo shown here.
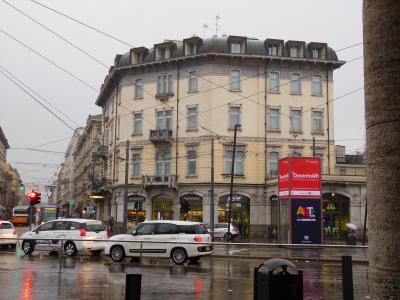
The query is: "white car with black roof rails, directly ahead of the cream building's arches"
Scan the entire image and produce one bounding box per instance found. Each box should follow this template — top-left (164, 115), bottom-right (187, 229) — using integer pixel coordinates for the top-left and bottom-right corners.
top-left (104, 221), bottom-right (212, 264)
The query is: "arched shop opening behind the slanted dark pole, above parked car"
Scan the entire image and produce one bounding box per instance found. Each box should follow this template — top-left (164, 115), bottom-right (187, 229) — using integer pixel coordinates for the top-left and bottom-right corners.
top-left (218, 194), bottom-right (250, 237)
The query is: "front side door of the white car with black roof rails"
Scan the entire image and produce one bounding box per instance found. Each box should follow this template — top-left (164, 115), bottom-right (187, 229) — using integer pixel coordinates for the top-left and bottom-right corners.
top-left (125, 223), bottom-right (156, 257)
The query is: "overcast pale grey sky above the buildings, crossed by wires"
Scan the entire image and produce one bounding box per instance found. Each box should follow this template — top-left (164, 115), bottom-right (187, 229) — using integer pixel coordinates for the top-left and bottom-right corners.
top-left (0, 0), bottom-right (365, 193)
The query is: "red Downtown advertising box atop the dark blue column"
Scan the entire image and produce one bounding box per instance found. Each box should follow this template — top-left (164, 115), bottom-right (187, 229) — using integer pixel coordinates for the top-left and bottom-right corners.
top-left (278, 157), bottom-right (321, 199)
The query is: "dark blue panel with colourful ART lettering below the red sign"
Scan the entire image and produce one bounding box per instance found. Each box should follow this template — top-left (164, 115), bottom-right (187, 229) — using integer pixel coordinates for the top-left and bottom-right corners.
top-left (290, 199), bottom-right (322, 244)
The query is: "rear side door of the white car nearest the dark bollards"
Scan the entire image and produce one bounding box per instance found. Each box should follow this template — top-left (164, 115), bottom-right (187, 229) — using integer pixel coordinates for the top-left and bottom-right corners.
top-left (151, 223), bottom-right (178, 257)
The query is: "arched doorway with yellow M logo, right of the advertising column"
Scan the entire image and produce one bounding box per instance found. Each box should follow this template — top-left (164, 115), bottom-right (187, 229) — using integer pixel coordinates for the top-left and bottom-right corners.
top-left (322, 193), bottom-right (350, 240)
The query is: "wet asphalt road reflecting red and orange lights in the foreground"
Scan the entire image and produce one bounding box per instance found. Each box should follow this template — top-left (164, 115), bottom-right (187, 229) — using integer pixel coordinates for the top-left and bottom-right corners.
top-left (0, 251), bottom-right (368, 300)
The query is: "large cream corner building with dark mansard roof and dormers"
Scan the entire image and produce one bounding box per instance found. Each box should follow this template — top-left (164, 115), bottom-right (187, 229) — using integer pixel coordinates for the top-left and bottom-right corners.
top-left (96, 36), bottom-right (365, 235)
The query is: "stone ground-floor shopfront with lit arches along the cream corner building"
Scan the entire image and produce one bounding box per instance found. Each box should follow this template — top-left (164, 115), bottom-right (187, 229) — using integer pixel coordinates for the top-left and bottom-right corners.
top-left (98, 178), bottom-right (366, 240)
